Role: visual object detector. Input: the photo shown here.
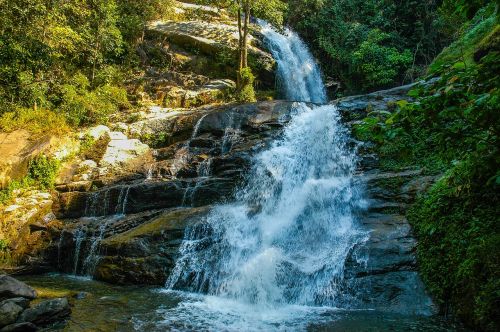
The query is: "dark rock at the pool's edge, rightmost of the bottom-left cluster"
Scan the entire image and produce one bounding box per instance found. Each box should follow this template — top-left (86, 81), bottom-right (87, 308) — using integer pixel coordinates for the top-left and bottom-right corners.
top-left (18, 298), bottom-right (71, 326)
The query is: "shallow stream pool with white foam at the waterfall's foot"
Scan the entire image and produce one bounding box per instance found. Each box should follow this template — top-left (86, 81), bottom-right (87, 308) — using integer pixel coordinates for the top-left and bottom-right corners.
top-left (19, 274), bottom-right (462, 332)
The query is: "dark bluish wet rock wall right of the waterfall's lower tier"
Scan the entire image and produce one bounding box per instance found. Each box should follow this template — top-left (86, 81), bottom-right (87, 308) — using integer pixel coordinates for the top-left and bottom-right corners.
top-left (344, 168), bottom-right (436, 315)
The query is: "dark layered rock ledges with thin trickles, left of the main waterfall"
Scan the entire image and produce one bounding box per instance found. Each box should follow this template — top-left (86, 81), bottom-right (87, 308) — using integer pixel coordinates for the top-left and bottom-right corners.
top-left (52, 101), bottom-right (294, 284)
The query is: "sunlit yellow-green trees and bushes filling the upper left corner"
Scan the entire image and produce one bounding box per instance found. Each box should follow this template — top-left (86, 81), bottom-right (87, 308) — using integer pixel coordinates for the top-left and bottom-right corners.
top-left (0, 0), bottom-right (176, 133)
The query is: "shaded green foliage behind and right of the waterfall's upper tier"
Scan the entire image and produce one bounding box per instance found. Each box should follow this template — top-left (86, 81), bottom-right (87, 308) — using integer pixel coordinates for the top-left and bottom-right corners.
top-left (287, 0), bottom-right (454, 93)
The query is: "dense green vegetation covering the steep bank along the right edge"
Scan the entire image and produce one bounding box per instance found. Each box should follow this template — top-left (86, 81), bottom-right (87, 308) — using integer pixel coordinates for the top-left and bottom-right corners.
top-left (355, 5), bottom-right (500, 331)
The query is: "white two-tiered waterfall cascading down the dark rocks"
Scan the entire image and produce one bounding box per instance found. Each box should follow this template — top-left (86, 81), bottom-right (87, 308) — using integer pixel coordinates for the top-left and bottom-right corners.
top-left (166, 24), bottom-right (365, 308)
